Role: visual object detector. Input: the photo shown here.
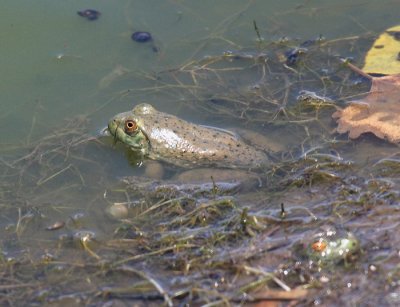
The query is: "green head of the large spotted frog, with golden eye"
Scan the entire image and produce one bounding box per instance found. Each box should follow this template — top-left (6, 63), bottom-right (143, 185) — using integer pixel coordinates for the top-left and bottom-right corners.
top-left (108, 107), bottom-right (150, 156)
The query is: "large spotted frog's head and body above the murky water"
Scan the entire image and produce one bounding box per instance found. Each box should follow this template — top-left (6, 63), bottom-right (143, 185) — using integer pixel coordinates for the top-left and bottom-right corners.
top-left (108, 104), bottom-right (268, 169)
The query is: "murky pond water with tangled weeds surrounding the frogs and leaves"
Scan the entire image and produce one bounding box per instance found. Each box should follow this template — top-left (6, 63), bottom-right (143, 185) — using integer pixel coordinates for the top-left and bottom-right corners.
top-left (0, 0), bottom-right (400, 306)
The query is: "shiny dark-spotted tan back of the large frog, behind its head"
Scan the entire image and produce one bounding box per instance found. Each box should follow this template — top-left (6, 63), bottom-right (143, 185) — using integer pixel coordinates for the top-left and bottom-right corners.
top-left (133, 105), bottom-right (268, 169)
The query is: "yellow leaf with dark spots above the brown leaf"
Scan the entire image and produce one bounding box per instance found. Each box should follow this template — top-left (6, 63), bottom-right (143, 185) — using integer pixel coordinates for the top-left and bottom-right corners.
top-left (362, 25), bottom-right (400, 75)
